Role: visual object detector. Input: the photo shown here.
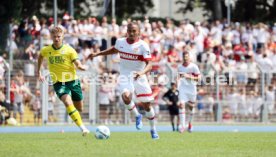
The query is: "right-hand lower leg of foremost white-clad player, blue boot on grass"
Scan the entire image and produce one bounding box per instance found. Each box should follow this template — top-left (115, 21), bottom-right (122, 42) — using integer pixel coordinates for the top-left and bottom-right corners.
top-left (142, 102), bottom-right (159, 139)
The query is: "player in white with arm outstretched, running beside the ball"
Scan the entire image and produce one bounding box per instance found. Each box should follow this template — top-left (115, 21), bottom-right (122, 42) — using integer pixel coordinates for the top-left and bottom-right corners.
top-left (91, 23), bottom-right (159, 139)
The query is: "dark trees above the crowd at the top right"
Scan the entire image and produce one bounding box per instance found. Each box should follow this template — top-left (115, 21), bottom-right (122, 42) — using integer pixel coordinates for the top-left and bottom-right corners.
top-left (176, 0), bottom-right (276, 22)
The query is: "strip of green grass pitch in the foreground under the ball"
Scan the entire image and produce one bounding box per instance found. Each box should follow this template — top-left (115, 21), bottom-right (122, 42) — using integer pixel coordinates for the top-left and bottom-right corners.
top-left (0, 132), bottom-right (276, 157)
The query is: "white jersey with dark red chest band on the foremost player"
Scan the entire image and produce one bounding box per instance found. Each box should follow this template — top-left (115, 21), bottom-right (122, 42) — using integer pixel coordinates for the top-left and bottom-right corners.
top-left (115, 38), bottom-right (151, 76)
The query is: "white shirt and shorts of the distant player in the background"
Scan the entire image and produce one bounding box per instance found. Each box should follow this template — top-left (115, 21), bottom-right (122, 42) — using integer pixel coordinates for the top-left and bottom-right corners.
top-left (178, 62), bottom-right (200, 95)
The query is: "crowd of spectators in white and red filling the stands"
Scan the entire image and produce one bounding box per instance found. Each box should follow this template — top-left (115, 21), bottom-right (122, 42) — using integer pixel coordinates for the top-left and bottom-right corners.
top-left (0, 14), bottom-right (276, 125)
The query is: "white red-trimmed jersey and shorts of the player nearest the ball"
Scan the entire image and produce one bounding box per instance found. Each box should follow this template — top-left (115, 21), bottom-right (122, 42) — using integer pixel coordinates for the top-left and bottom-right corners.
top-left (115, 38), bottom-right (153, 102)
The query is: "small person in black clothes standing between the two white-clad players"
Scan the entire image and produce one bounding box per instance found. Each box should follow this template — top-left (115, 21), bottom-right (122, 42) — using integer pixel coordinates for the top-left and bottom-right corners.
top-left (163, 82), bottom-right (179, 131)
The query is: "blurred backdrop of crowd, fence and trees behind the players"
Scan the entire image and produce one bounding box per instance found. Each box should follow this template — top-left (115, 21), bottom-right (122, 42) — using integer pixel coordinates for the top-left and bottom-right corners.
top-left (0, 0), bottom-right (276, 125)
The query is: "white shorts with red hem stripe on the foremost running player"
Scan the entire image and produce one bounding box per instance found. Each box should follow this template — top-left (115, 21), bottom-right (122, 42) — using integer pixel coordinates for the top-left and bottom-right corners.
top-left (119, 75), bottom-right (154, 102)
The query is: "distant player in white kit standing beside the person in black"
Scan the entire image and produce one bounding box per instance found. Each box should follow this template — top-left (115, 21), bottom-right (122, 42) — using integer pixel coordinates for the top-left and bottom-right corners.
top-left (178, 52), bottom-right (200, 133)
